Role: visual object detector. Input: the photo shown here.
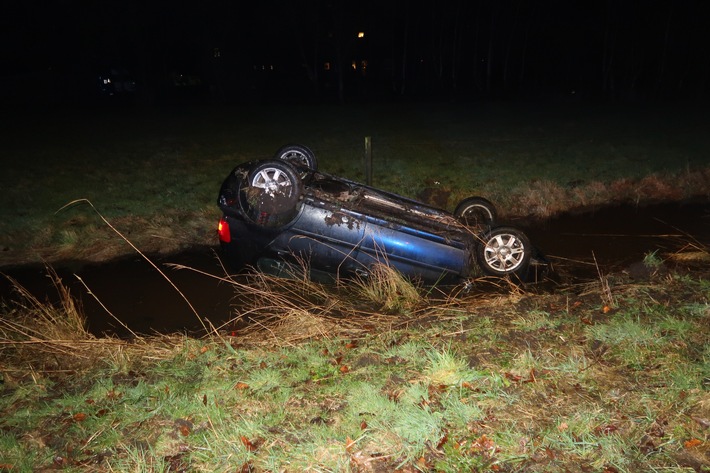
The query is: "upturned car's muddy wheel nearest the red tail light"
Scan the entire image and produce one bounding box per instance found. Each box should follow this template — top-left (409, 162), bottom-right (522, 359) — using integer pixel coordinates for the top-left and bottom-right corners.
top-left (240, 161), bottom-right (303, 228)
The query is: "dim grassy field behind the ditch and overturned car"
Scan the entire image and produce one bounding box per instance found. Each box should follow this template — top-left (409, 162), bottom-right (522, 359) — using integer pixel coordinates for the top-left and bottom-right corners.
top-left (0, 99), bottom-right (710, 266)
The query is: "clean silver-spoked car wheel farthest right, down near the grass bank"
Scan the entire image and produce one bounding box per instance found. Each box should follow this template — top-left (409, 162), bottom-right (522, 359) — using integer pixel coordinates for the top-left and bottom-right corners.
top-left (477, 227), bottom-right (531, 277)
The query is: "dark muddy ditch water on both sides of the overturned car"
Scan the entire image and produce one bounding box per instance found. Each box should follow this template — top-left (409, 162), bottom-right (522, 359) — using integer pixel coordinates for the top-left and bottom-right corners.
top-left (0, 199), bottom-right (710, 337)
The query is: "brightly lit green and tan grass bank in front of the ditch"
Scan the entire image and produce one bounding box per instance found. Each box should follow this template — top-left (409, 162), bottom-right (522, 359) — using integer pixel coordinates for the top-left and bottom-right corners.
top-left (0, 243), bottom-right (710, 472)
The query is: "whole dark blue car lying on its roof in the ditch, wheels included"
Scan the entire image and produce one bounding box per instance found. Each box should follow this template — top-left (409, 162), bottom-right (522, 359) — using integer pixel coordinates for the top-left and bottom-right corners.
top-left (218, 145), bottom-right (546, 284)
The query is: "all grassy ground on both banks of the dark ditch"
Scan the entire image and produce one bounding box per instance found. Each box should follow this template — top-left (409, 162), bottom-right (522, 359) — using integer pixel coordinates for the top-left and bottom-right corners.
top-left (0, 103), bottom-right (710, 473)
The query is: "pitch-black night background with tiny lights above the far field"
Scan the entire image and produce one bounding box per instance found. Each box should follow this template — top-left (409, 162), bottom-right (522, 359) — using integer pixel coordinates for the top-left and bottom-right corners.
top-left (0, 0), bottom-right (710, 103)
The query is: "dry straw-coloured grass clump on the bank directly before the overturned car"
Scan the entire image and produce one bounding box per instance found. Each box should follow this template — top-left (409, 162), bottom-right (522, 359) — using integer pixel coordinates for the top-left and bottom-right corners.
top-left (217, 256), bottom-right (490, 346)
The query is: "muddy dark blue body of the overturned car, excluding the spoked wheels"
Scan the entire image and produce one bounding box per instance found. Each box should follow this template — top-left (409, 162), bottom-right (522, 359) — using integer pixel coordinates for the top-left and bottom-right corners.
top-left (218, 156), bottom-right (544, 284)
